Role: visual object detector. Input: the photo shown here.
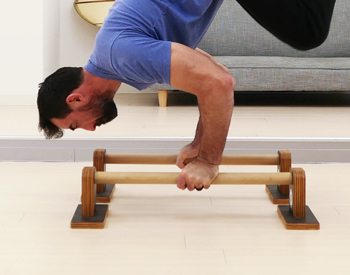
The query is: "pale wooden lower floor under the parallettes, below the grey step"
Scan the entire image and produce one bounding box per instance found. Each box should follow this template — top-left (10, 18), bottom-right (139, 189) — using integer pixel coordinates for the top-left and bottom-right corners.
top-left (0, 163), bottom-right (350, 275)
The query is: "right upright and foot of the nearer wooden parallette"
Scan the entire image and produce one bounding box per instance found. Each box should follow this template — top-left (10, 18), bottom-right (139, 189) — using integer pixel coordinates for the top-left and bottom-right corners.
top-left (278, 168), bottom-right (320, 230)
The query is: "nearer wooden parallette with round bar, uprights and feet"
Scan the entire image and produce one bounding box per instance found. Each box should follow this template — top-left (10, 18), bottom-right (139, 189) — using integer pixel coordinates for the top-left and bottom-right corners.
top-left (71, 167), bottom-right (319, 229)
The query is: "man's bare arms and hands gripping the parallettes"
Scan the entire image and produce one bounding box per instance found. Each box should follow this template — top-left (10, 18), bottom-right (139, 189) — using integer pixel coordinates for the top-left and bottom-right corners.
top-left (171, 43), bottom-right (235, 191)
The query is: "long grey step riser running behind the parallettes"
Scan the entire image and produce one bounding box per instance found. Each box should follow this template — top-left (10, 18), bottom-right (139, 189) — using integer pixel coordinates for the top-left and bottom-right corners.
top-left (0, 138), bottom-right (350, 163)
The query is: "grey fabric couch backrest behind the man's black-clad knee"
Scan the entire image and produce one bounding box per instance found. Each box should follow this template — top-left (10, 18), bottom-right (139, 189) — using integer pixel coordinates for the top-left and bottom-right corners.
top-left (199, 0), bottom-right (350, 57)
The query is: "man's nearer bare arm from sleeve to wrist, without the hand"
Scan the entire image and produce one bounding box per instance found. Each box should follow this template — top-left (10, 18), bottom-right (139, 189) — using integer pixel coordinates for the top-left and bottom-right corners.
top-left (170, 43), bottom-right (235, 164)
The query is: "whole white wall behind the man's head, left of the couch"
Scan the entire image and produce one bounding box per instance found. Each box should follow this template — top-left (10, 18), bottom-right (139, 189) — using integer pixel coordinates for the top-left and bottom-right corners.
top-left (0, 0), bottom-right (139, 105)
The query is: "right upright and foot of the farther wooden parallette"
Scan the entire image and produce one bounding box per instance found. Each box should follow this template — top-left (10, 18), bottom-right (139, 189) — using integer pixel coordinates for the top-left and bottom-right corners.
top-left (266, 150), bottom-right (292, 204)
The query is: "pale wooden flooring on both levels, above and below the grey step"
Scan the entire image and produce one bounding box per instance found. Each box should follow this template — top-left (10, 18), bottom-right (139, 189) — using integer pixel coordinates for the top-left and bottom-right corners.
top-left (0, 92), bottom-right (350, 275)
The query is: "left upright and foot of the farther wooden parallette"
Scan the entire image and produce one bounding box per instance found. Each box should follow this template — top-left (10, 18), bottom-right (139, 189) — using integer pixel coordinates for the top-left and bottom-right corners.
top-left (93, 149), bottom-right (114, 203)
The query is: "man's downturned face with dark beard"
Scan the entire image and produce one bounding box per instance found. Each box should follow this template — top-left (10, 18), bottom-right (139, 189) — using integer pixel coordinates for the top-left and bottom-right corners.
top-left (51, 100), bottom-right (118, 131)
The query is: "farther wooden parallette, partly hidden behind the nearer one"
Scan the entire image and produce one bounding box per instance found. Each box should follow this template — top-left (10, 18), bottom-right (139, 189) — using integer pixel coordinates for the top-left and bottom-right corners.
top-left (93, 149), bottom-right (291, 204)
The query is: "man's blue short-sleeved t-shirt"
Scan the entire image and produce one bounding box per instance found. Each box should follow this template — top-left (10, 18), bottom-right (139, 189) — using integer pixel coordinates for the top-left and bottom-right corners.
top-left (86, 0), bottom-right (223, 89)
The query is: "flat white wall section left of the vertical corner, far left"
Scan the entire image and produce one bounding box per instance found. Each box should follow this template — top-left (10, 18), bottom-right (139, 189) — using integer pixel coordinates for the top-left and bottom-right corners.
top-left (0, 0), bottom-right (43, 104)
